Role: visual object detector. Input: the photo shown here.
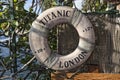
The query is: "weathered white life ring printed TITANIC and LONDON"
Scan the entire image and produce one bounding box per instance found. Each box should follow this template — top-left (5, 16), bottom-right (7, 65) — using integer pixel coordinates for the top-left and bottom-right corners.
top-left (29, 6), bottom-right (95, 70)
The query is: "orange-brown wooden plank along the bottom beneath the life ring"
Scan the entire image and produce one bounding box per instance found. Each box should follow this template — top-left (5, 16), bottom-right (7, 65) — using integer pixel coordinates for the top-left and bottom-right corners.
top-left (52, 73), bottom-right (120, 80)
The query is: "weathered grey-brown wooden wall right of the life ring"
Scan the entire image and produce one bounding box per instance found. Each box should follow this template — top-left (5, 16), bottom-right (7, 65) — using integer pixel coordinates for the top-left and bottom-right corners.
top-left (88, 14), bottom-right (120, 73)
